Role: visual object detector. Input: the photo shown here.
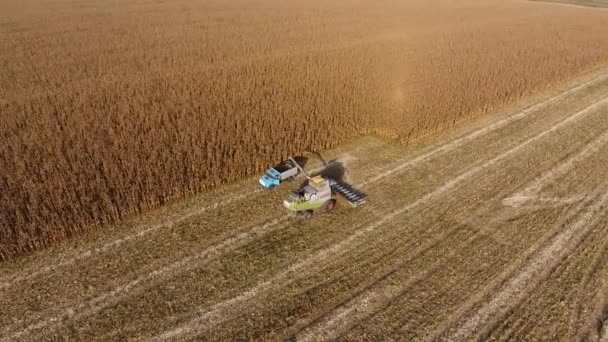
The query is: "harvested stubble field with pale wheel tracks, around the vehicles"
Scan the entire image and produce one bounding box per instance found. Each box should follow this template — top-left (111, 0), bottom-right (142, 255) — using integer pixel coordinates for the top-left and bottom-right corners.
top-left (0, 70), bottom-right (608, 341)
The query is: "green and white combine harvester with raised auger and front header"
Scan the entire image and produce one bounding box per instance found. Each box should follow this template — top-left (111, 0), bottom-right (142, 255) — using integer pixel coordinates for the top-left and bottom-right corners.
top-left (283, 157), bottom-right (365, 219)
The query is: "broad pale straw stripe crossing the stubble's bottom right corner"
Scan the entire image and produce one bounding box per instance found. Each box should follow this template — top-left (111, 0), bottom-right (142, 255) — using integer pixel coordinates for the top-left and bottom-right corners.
top-left (445, 187), bottom-right (608, 341)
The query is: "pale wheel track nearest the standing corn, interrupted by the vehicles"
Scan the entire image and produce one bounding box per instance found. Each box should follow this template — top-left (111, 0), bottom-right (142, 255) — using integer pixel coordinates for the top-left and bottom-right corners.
top-left (0, 73), bottom-right (608, 290)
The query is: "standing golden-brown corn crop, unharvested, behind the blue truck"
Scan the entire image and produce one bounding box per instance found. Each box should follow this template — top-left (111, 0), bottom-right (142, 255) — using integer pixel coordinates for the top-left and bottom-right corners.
top-left (0, 0), bottom-right (608, 259)
